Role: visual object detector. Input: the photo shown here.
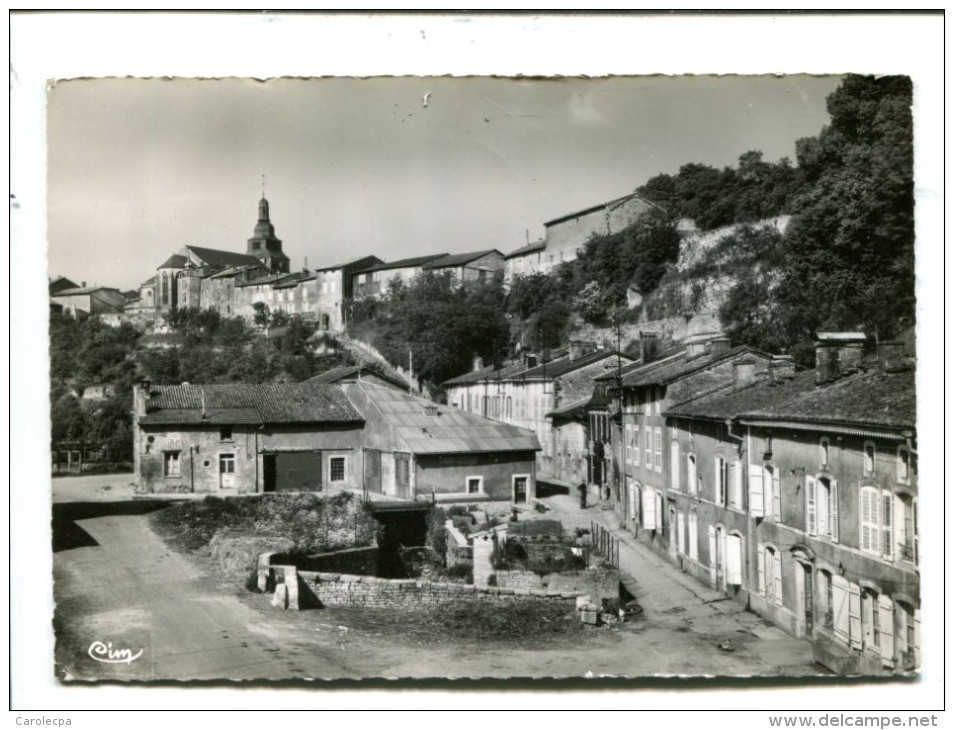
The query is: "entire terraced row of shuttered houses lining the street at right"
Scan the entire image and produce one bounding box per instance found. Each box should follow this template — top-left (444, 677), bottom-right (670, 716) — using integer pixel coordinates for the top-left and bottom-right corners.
top-left (445, 333), bottom-right (921, 674)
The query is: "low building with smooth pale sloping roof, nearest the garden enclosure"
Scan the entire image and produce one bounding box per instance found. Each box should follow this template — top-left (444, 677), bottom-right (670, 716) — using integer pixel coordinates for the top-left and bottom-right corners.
top-left (341, 379), bottom-right (540, 504)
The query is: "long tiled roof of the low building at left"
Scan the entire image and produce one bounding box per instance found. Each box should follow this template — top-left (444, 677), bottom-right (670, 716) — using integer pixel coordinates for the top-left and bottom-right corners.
top-left (139, 383), bottom-right (363, 425)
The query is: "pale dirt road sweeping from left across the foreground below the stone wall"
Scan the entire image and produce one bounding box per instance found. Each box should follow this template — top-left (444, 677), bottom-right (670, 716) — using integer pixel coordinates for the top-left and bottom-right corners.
top-left (54, 503), bottom-right (819, 680)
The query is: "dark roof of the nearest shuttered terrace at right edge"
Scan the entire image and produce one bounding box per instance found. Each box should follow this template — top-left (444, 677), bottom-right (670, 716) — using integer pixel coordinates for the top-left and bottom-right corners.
top-left (666, 366), bottom-right (917, 429)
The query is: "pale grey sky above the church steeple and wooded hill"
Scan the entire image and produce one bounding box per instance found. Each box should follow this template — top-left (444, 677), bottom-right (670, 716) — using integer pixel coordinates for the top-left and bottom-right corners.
top-left (47, 75), bottom-right (840, 290)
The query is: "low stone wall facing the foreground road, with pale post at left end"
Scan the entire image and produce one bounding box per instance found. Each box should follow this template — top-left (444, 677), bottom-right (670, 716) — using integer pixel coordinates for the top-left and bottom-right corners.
top-left (271, 565), bottom-right (578, 611)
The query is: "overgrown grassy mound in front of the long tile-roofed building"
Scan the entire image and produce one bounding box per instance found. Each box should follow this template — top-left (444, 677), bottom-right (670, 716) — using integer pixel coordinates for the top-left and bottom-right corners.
top-left (150, 492), bottom-right (377, 554)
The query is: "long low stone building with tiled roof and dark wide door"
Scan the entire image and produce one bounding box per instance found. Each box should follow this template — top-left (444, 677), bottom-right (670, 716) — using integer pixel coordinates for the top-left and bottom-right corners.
top-left (133, 382), bottom-right (364, 494)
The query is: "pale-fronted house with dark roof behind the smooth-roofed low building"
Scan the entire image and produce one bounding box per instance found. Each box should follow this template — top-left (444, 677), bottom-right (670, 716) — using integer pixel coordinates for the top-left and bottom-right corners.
top-left (444, 342), bottom-right (632, 476)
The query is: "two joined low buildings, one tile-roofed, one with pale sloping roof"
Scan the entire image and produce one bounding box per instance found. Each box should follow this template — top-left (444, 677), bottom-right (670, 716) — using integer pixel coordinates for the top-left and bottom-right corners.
top-left (133, 372), bottom-right (540, 504)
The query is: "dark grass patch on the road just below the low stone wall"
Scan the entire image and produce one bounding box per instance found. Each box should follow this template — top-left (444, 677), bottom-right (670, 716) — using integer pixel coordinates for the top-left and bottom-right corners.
top-left (428, 601), bottom-right (580, 639)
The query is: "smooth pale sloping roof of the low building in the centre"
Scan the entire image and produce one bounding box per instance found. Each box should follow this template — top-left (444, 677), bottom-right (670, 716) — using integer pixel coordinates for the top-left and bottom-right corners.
top-left (341, 380), bottom-right (540, 455)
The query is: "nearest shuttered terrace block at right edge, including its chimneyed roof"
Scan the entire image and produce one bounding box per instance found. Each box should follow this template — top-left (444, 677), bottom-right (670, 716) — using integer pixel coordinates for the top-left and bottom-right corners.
top-left (654, 333), bottom-right (921, 674)
